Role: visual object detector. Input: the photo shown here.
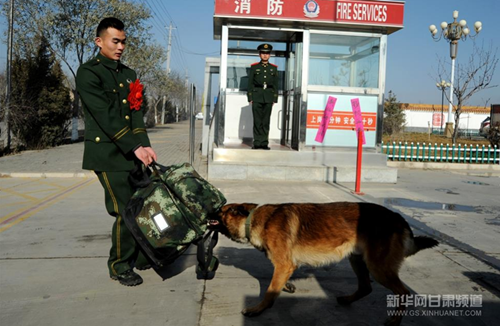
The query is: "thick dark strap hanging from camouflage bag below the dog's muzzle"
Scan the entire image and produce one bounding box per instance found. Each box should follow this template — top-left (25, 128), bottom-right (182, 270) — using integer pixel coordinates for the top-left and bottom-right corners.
top-left (196, 231), bottom-right (219, 279)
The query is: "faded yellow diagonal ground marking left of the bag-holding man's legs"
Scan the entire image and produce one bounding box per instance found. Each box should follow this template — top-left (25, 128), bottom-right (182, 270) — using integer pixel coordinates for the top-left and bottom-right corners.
top-left (0, 178), bottom-right (97, 232)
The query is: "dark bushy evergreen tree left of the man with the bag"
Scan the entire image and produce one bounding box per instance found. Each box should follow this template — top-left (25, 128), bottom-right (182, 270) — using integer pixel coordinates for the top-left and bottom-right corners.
top-left (10, 37), bottom-right (71, 149)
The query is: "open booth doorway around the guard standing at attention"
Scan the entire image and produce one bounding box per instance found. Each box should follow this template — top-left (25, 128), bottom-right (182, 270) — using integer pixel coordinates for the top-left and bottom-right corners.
top-left (221, 26), bottom-right (304, 150)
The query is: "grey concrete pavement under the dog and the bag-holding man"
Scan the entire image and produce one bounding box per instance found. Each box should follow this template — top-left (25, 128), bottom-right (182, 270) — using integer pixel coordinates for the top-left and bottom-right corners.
top-left (0, 123), bottom-right (500, 326)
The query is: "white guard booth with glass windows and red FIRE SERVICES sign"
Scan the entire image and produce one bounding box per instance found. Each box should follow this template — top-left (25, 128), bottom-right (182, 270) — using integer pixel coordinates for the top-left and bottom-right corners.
top-left (205, 0), bottom-right (404, 181)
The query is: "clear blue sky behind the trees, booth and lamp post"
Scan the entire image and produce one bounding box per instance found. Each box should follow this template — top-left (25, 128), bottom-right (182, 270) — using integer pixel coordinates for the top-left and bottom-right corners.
top-left (0, 0), bottom-right (500, 106)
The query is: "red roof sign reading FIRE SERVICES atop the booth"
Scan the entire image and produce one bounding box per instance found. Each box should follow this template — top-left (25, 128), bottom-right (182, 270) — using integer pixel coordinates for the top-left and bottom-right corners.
top-left (215, 0), bottom-right (404, 27)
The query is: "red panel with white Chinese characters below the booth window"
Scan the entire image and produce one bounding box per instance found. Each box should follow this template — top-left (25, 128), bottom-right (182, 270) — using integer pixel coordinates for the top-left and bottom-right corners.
top-left (307, 110), bottom-right (377, 131)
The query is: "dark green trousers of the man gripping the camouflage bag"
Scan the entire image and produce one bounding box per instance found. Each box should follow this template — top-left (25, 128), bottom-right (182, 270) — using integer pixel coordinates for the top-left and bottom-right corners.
top-left (95, 171), bottom-right (149, 276)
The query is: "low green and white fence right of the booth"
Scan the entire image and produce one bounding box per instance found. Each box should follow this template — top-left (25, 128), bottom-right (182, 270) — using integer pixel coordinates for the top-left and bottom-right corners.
top-left (382, 142), bottom-right (500, 164)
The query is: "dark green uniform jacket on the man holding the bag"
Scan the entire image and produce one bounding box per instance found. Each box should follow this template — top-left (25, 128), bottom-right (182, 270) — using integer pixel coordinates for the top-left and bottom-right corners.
top-left (76, 53), bottom-right (151, 171)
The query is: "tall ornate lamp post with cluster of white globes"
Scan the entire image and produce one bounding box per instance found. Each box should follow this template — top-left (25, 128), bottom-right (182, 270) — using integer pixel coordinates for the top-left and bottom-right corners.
top-left (429, 10), bottom-right (482, 138)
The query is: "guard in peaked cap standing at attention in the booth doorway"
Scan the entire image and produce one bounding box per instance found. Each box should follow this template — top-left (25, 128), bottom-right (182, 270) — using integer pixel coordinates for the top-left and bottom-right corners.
top-left (247, 43), bottom-right (278, 150)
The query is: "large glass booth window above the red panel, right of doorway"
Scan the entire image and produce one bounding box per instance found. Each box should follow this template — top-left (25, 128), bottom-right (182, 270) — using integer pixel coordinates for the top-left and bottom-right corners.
top-left (309, 34), bottom-right (380, 88)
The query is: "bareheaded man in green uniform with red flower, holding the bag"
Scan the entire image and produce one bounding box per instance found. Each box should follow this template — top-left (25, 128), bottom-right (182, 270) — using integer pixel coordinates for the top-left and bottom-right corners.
top-left (76, 17), bottom-right (156, 286)
